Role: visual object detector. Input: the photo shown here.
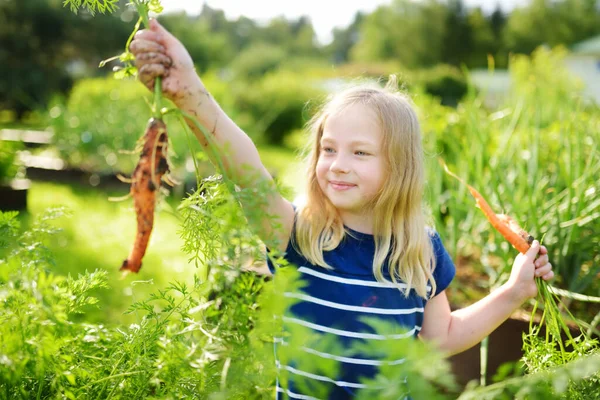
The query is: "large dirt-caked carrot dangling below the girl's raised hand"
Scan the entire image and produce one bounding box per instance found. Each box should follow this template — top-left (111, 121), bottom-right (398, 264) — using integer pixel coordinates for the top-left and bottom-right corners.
top-left (121, 118), bottom-right (169, 272)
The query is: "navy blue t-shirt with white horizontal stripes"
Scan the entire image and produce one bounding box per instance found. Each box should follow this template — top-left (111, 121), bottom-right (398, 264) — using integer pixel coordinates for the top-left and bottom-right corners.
top-left (269, 228), bottom-right (455, 400)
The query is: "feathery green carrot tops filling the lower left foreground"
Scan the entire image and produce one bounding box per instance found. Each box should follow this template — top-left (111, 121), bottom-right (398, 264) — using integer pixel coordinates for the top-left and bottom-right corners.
top-left (0, 200), bottom-right (276, 399)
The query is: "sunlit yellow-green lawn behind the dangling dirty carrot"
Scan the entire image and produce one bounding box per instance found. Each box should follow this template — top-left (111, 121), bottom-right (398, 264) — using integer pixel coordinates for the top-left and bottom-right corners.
top-left (22, 182), bottom-right (197, 324)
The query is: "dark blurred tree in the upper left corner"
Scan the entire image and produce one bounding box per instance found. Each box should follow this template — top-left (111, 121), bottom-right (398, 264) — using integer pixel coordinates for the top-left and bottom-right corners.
top-left (0, 0), bottom-right (131, 120)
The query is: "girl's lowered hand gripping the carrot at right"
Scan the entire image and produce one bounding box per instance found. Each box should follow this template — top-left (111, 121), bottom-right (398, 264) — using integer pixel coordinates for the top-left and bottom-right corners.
top-left (507, 240), bottom-right (554, 302)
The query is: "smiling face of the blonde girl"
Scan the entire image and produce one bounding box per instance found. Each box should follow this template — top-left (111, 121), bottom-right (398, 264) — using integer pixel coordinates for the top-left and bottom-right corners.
top-left (316, 104), bottom-right (385, 219)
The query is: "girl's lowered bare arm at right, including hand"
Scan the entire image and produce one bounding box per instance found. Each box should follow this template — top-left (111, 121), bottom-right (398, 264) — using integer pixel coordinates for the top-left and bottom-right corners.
top-left (419, 241), bottom-right (554, 355)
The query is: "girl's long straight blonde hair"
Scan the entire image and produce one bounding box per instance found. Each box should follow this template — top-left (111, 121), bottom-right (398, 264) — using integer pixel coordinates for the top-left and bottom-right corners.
top-left (291, 76), bottom-right (436, 298)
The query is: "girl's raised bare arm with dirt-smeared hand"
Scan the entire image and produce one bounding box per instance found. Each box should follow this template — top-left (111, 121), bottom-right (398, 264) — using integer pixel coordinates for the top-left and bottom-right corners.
top-left (130, 20), bottom-right (294, 251)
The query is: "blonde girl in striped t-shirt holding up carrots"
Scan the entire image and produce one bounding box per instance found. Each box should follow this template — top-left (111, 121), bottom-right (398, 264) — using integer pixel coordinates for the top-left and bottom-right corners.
top-left (131, 20), bottom-right (553, 399)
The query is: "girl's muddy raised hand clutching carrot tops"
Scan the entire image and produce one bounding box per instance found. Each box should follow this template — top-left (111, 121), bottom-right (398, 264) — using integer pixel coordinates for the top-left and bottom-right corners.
top-left (129, 19), bottom-right (205, 108)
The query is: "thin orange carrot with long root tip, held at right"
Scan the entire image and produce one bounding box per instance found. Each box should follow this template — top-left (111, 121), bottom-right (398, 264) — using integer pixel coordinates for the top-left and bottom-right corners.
top-left (440, 160), bottom-right (533, 254)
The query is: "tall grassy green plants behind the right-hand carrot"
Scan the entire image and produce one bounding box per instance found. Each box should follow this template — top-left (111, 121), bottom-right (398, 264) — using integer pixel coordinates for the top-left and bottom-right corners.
top-left (417, 47), bottom-right (600, 294)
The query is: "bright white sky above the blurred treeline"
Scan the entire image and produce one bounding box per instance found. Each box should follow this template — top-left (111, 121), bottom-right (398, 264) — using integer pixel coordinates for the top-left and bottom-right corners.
top-left (161, 0), bottom-right (528, 44)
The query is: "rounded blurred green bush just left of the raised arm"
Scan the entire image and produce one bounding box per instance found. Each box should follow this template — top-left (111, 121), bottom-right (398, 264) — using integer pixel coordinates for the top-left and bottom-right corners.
top-left (50, 78), bottom-right (193, 171)
